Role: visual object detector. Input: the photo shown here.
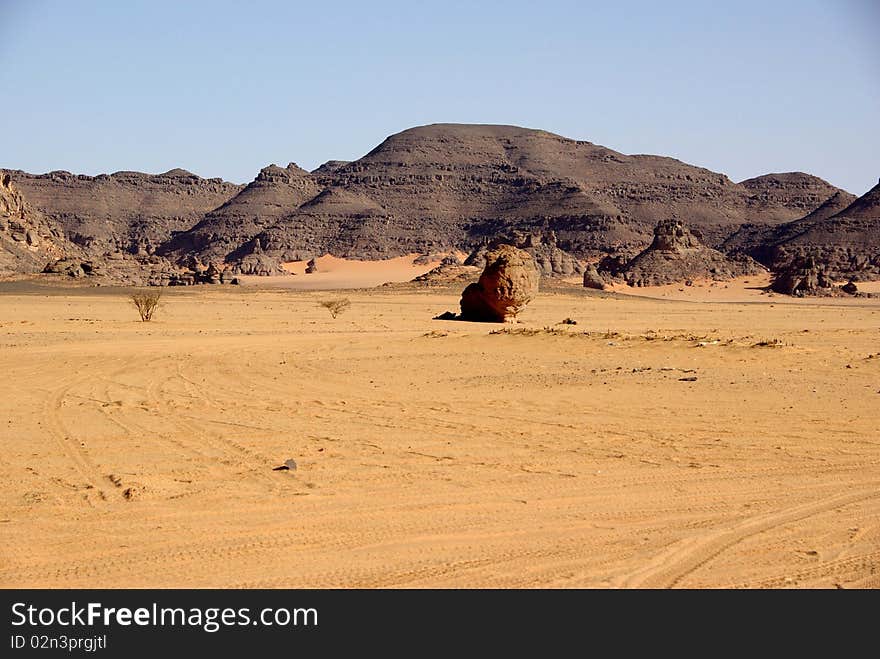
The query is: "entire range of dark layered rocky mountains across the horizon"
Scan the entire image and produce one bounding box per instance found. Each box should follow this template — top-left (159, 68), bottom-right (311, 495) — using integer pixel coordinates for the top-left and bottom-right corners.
top-left (10, 124), bottom-right (876, 288)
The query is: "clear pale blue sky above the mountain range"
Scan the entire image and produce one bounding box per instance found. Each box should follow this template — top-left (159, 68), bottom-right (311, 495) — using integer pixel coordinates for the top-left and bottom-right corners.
top-left (0, 0), bottom-right (880, 194)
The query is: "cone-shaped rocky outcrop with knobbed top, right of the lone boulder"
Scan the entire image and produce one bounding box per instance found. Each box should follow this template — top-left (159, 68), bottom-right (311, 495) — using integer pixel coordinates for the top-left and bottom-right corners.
top-left (608, 219), bottom-right (763, 286)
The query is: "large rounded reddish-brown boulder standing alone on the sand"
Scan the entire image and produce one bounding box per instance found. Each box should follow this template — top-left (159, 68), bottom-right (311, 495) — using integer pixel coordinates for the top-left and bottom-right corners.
top-left (460, 245), bottom-right (540, 322)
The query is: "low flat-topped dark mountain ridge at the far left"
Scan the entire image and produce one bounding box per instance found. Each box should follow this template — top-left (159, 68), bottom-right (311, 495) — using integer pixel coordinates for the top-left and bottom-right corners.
top-left (9, 169), bottom-right (242, 255)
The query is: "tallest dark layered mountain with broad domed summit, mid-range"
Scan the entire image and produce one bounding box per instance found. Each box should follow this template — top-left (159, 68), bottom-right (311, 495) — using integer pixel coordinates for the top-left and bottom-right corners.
top-left (160, 124), bottom-right (838, 272)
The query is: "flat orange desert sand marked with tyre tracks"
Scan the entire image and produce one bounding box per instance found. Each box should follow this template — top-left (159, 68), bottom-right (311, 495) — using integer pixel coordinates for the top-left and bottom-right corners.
top-left (0, 266), bottom-right (880, 588)
